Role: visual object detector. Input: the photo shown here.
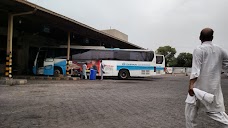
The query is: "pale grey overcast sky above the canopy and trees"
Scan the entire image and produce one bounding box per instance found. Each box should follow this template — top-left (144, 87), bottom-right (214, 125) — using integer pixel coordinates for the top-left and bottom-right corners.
top-left (29, 0), bottom-right (228, 53)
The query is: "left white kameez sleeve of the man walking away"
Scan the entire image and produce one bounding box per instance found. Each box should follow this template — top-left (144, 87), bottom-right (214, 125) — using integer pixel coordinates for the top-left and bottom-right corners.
top-left (190, 48), bottom-right (203, 79)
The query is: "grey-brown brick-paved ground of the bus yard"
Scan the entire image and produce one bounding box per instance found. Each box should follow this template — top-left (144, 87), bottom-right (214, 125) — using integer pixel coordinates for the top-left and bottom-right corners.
top-left (0, 76), bottom-right (228, 128)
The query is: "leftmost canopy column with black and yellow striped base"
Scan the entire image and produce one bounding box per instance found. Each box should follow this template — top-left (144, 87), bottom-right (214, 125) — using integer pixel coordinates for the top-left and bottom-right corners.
top-left (5, 14), bottom-right (13, 78)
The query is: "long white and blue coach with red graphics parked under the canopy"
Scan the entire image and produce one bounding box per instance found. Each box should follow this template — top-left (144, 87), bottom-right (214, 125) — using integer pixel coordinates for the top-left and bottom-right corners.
top-left (33, 46), bottom-right (156, 79)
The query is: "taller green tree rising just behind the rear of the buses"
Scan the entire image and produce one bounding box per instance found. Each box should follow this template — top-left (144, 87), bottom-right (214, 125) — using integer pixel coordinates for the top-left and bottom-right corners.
top-left (156, 46), bottom-right (177, 66)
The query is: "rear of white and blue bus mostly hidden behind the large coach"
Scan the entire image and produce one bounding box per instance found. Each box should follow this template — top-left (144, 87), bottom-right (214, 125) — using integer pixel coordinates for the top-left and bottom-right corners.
top-left (156, 54), bottom-right (166, 75)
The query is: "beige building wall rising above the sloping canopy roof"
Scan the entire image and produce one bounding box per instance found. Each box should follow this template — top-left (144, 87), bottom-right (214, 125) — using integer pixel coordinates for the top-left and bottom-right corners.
top-left (101, 29), bottom-right (128, 42)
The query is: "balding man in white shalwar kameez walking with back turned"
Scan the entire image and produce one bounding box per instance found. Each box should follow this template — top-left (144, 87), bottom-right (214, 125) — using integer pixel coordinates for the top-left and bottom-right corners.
top-left (185, 28), bottom-right (228, 128)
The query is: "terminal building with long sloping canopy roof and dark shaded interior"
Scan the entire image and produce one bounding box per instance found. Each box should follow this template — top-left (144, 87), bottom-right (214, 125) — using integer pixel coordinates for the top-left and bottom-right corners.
top-left (0, 0), bottom-right (143, 76)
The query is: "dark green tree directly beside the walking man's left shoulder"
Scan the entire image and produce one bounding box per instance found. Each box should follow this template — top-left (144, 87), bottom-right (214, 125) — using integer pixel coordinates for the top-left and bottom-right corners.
top-left (177, 52), bottom-right (192, 67)
